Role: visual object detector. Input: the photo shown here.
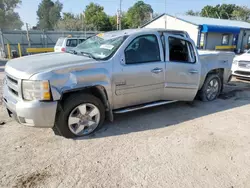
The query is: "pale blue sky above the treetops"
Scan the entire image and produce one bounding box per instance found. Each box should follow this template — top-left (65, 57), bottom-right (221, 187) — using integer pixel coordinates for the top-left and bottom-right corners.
top-left (17, 0), bottom-right (250, 26)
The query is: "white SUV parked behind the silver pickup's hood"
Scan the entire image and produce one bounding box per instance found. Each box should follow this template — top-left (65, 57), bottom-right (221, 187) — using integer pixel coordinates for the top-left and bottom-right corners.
top-left (54, 37), bottom-right (86, 52)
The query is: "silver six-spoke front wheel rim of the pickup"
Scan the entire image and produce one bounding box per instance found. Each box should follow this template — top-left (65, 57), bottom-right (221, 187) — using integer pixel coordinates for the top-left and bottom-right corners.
top-left (68, 103), bottom-right (100, 136)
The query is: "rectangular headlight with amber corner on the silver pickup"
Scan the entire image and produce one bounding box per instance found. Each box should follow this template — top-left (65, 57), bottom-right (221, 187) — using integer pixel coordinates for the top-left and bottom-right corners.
top-left (22, 80), bottom-right (52, 101)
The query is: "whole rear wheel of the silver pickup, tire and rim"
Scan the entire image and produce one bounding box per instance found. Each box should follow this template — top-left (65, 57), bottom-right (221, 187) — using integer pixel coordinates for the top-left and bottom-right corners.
top-left (200, 74), bottom-right (222, 101)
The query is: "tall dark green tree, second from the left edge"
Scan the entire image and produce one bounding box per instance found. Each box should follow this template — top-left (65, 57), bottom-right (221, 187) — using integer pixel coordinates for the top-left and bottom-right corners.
top-left (37, 0), bottom-right (63, 30)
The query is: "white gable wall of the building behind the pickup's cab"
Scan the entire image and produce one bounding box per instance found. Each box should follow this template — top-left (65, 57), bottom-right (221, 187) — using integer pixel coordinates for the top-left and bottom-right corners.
top-left (145, 15), bottom-right (199, 45)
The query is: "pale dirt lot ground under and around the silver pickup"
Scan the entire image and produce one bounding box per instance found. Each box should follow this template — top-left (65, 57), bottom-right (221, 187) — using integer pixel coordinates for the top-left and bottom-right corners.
top-left (0, 65), bottom-right (250, 188)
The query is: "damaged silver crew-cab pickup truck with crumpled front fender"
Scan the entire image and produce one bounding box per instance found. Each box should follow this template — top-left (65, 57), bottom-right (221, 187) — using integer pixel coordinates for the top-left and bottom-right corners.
top-left (3, 29), bottom-right (234, 138)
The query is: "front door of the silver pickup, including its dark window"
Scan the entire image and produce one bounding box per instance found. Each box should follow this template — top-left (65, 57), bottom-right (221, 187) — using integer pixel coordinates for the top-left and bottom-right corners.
top-left (113, 34), bottom-right (165, 109)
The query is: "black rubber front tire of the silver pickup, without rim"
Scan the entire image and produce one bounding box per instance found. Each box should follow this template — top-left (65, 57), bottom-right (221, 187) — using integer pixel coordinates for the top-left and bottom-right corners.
top-left (53, 93), bottom-right (105, 138)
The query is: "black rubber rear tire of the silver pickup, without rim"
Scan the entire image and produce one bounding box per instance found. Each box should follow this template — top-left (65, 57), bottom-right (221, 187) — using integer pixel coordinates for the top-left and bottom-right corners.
top-left (199, 74), bottom-right (222, 102)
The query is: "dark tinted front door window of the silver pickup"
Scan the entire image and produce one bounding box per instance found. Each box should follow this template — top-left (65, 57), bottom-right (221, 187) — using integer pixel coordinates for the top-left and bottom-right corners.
top-left (125, 35), bottom-right (161, 64)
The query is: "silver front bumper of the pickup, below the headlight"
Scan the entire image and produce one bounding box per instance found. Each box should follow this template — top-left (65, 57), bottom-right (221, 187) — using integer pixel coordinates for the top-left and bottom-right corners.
top-left (3, 81), bottom-right (57, 128)
